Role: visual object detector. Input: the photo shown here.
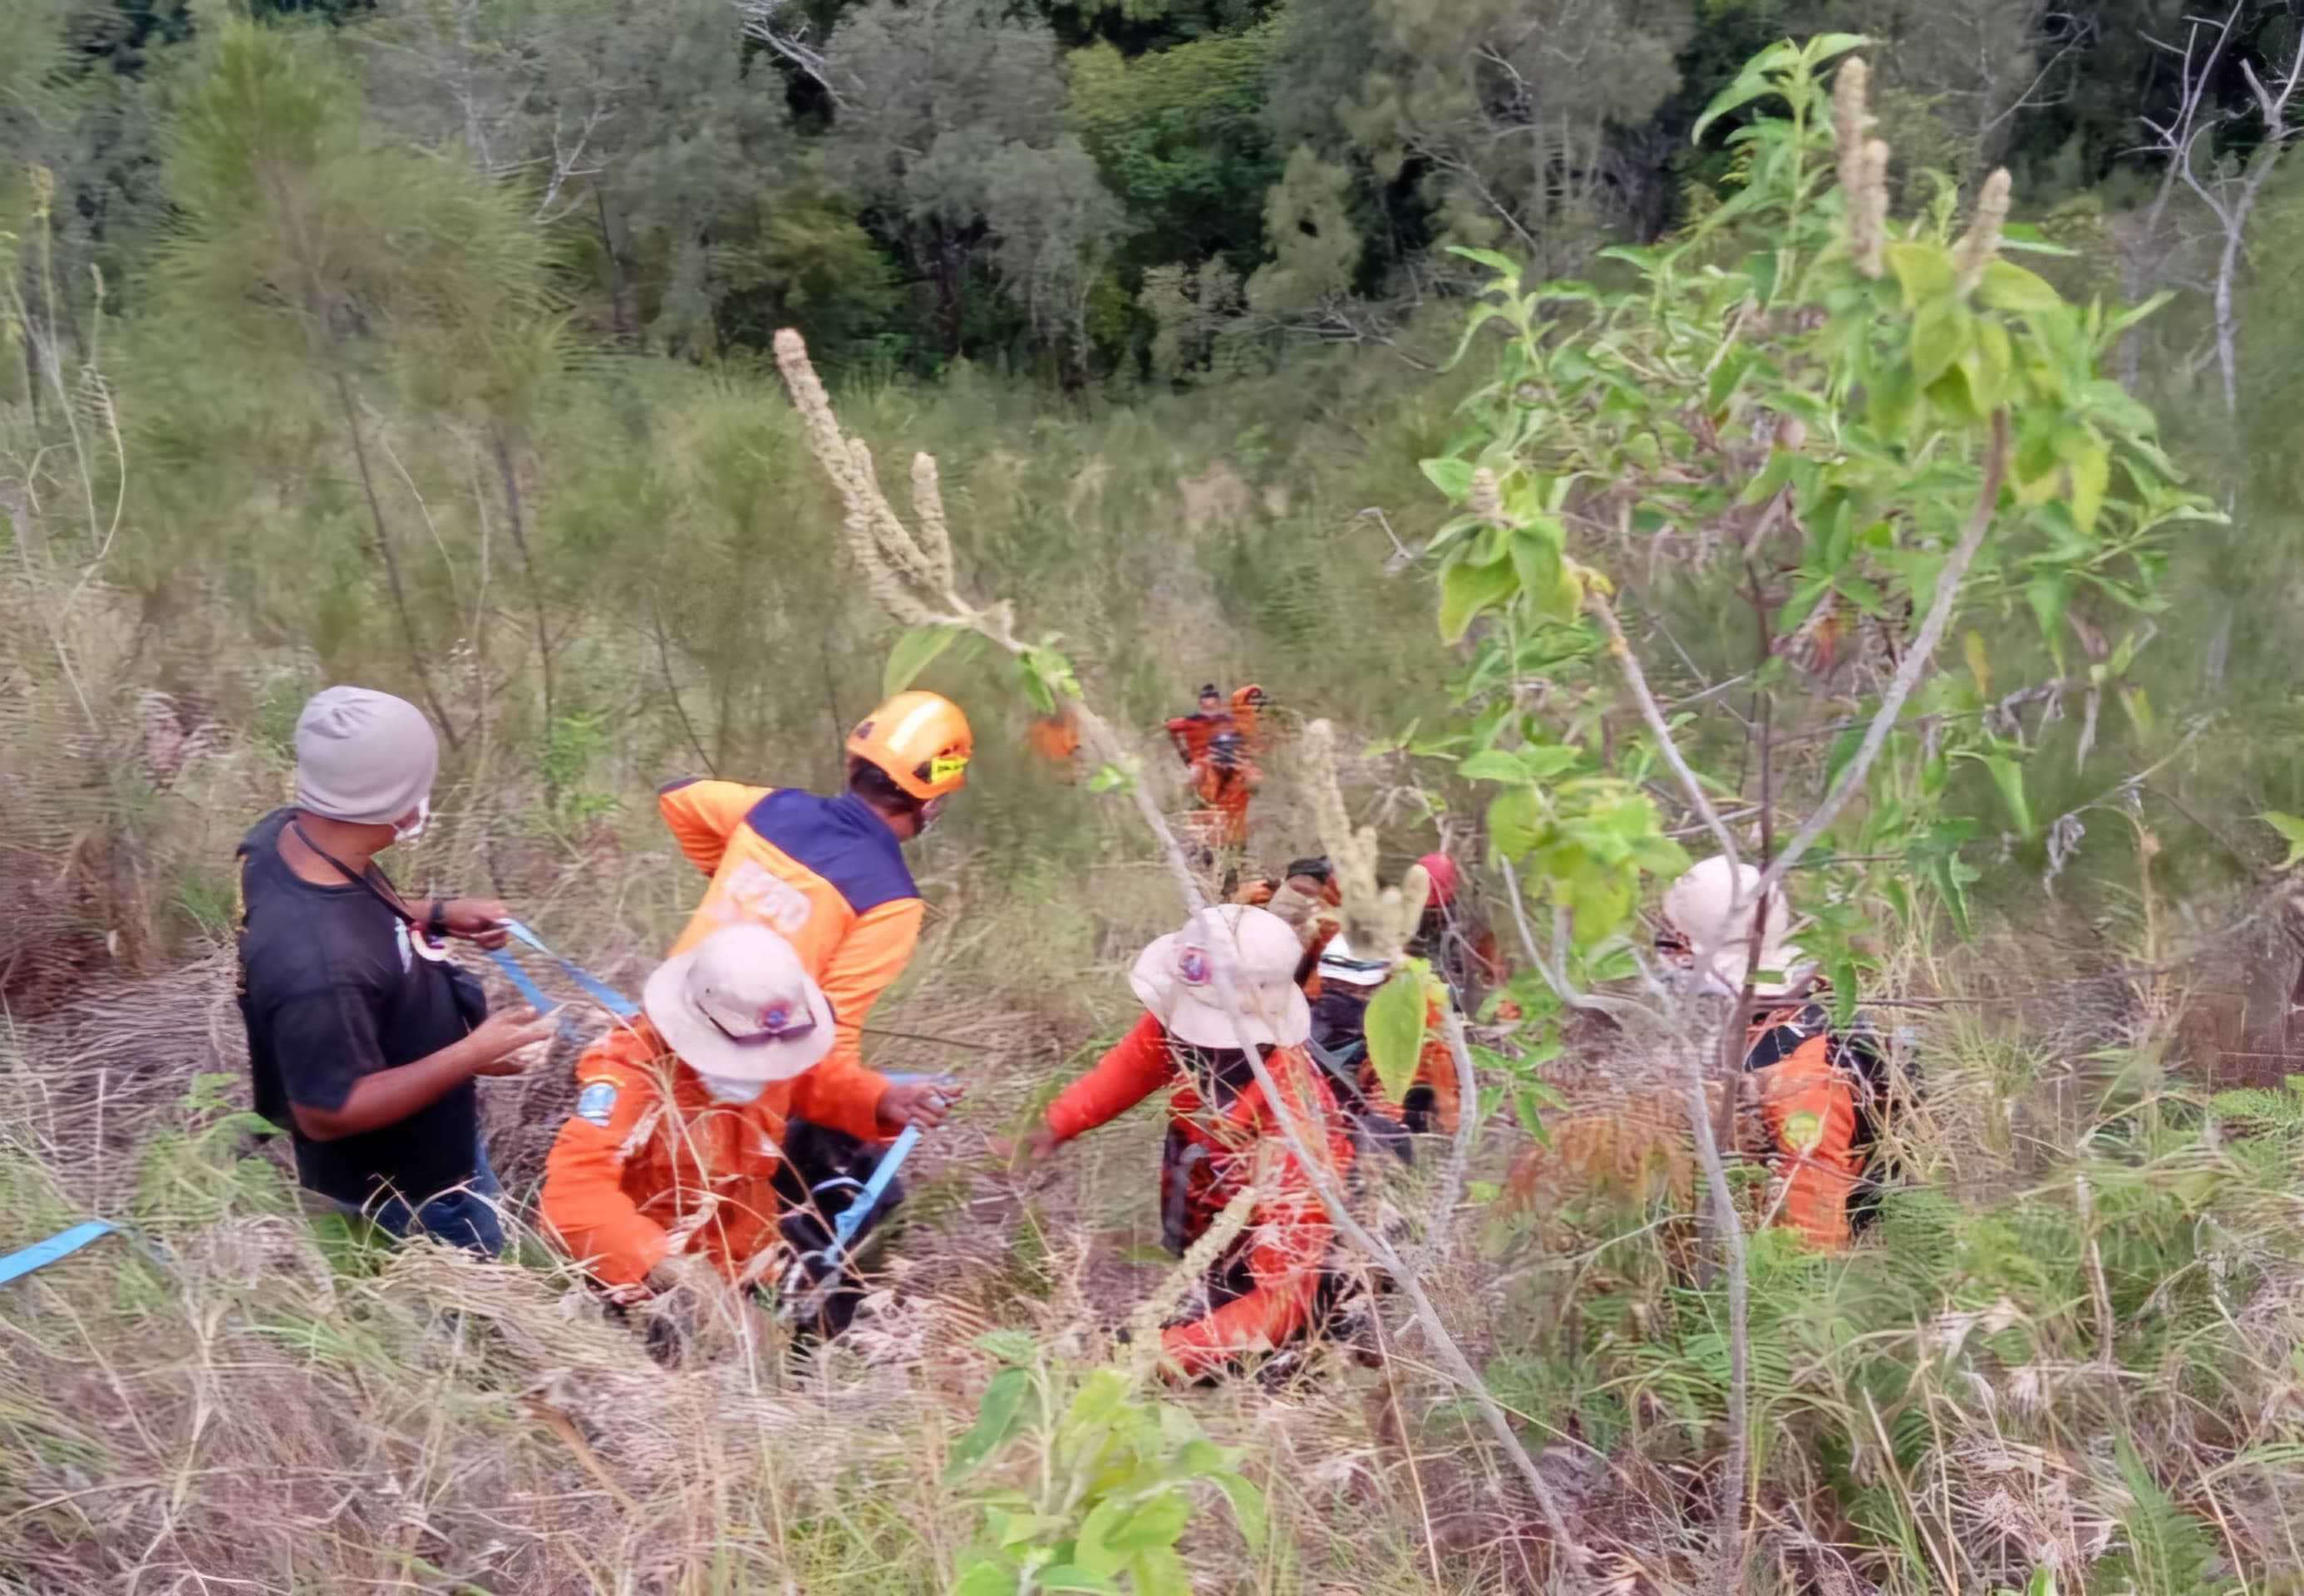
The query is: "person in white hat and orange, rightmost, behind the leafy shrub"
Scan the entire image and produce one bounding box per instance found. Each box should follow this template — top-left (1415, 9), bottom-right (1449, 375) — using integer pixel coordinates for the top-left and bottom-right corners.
top-left (1657, 857), bottom-right (1887, 1249)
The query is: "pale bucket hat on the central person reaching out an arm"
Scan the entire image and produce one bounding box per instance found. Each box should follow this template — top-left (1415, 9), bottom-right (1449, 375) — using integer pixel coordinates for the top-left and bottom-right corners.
top-left (1129, 903), bottom-right (1311, 1048)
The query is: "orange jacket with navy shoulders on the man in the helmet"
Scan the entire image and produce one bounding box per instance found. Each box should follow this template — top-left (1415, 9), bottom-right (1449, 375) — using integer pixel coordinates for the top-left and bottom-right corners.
top-left (657, 781), bottom-right (926, 1101)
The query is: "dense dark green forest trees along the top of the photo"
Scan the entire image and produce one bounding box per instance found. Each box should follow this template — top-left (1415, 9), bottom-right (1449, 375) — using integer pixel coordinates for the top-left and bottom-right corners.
top-left (17, 0), bottom-right (2297, 387)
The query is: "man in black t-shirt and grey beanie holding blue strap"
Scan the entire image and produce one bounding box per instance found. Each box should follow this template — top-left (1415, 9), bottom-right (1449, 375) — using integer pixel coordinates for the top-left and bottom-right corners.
top-left (238, 687), bottom-right (553, 1253)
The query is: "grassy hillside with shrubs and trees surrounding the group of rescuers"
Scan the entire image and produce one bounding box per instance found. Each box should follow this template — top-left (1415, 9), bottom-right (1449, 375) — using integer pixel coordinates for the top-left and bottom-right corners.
top-left (13, 0), bottom-right (2304, 1596)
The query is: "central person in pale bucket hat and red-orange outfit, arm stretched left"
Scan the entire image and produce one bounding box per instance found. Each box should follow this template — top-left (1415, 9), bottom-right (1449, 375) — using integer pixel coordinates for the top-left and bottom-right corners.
top-left (1023, 905), bottom-right (1352, 1377)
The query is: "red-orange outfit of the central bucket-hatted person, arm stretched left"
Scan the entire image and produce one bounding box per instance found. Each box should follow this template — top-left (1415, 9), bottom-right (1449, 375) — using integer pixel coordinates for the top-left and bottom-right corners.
top-left (1048, 1016), bottom-right (1352, 1375)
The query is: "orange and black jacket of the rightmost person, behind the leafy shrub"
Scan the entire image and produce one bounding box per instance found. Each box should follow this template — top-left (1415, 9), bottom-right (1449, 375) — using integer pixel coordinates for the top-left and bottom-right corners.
top-left (1744, 1002), bottom-right (1880, 1249)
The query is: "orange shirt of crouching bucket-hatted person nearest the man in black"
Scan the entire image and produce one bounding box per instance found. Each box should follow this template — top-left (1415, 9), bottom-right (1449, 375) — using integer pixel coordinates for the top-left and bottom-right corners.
top-left (541, 1020), bottom-right (883, 1288)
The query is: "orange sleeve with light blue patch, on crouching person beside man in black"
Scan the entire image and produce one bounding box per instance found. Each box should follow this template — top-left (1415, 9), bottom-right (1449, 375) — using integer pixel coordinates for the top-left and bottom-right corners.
top-left (539, 1027), bottom-right (671, 1285)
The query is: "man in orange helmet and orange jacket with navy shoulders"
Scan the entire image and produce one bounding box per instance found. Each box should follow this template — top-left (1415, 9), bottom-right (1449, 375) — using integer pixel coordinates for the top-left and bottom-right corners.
top-left (657, 693), bottom-right (975, 1133)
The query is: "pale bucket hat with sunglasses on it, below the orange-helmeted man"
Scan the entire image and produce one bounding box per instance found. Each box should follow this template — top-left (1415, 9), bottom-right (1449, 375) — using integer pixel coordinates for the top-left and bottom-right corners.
top-left (641, 924), bottom-right (836, 1080)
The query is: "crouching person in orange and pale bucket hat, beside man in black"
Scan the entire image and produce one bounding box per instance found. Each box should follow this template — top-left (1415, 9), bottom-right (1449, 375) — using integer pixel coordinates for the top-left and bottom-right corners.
top-left (541, 924), bottom-right (944, 1303)
